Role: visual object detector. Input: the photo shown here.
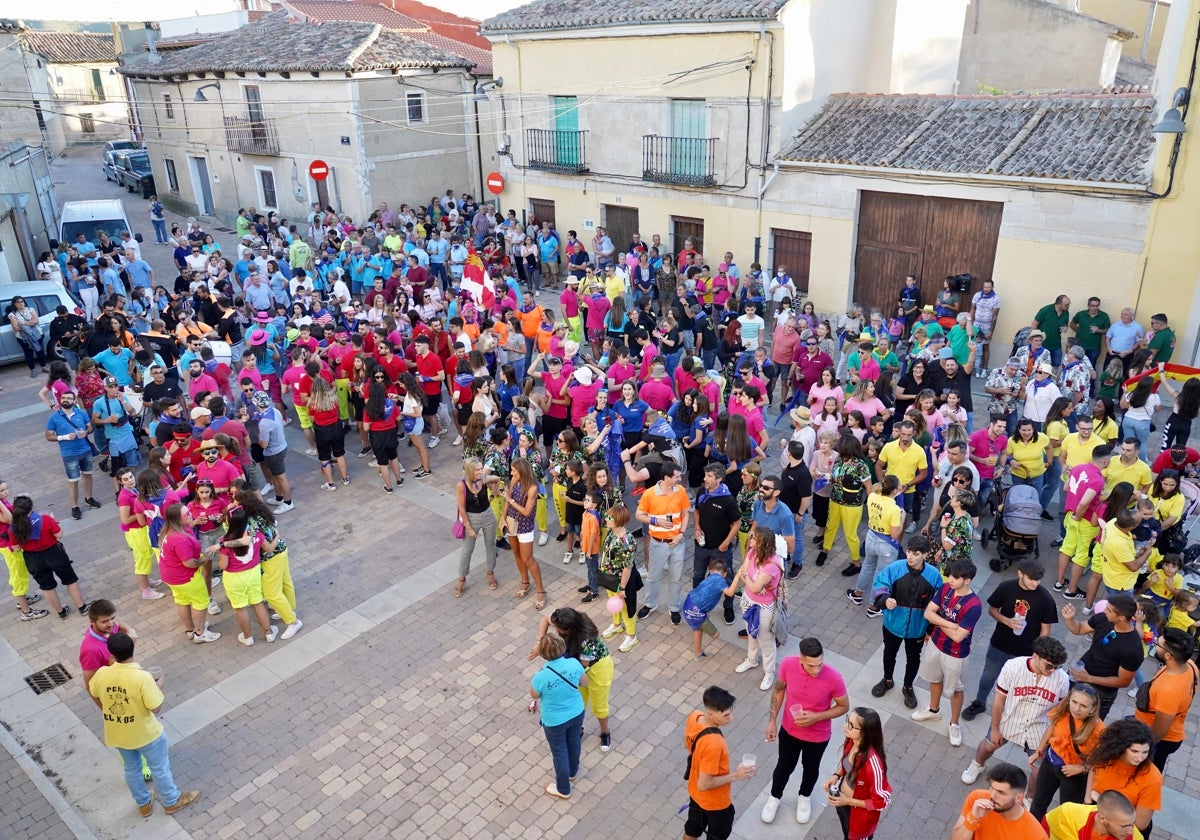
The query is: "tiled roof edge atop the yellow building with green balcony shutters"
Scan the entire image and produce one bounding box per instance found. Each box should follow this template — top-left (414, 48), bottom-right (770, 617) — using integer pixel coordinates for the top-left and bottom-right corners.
top-left (480, 0), bottom-right (787, 32)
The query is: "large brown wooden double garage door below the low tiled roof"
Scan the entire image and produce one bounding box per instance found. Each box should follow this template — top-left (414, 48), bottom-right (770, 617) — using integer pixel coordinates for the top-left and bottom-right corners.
top-left (854, 192), bottom-right (1004, 313)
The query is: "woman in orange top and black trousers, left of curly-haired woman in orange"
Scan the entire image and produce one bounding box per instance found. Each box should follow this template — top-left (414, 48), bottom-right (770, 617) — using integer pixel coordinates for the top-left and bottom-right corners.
top-left (1028, 683), bottom-right (1104, 820)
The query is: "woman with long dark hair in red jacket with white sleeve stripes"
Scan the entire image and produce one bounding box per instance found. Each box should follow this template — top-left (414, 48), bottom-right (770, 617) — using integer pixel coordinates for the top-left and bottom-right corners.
top-left (824, 706), bottom-right (892, 840)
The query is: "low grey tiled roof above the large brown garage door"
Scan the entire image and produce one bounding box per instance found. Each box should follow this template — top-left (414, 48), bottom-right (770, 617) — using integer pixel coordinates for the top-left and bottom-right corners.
top-left (779, 88), bottom-right (1156, 186)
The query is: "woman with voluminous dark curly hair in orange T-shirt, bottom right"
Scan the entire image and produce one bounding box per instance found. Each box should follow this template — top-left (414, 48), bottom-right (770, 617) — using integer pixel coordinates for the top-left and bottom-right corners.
top-left (1084, 718), bottom-right (1163, 836)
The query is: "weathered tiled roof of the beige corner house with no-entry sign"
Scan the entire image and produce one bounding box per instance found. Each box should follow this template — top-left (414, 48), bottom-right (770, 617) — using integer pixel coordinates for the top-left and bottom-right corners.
top-left (122, 12), bottom-right (473, 77)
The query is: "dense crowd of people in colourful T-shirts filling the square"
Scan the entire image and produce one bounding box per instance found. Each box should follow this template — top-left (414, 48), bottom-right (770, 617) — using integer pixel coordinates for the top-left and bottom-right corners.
top-left (0, 191), bottom-right (1200, 840)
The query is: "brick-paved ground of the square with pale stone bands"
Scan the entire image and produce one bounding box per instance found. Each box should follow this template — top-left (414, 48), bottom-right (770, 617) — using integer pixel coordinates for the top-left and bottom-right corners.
top-left (0, 151), bottom-right (1200, 840)
